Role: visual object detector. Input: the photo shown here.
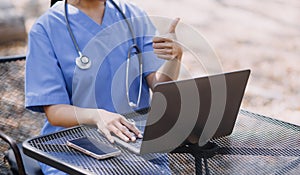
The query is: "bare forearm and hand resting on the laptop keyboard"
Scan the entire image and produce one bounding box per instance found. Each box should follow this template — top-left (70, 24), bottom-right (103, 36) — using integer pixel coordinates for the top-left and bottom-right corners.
top-left (44, 104), bottom-right (142, 143)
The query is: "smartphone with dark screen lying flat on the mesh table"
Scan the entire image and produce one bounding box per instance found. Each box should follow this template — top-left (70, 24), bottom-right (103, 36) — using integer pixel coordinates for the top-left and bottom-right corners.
top-left (67, 137), bottom-right (121, 159)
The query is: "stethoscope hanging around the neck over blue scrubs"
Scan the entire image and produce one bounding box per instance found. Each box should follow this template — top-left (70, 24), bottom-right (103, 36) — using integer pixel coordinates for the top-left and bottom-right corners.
top-left (64, 0), bottom-right (143, 108)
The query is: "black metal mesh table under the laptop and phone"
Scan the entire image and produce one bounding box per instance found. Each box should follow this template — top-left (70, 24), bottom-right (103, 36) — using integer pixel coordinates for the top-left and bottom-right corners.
top-left (23, 110), bottom-right (300, 174)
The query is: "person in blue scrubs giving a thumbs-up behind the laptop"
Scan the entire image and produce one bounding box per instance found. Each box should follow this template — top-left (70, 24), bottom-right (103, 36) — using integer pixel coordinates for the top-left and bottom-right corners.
top-left (25, 0), bottom-right (182, 174)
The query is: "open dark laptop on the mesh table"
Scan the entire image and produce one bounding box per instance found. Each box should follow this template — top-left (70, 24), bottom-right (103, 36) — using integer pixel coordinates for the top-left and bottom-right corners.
top-left (115, 70), bottom-right (250, 155)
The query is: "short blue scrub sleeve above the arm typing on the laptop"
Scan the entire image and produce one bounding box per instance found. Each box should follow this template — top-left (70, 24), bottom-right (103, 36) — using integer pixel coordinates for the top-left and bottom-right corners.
top-left (25, 23), bottom-right (70, 112)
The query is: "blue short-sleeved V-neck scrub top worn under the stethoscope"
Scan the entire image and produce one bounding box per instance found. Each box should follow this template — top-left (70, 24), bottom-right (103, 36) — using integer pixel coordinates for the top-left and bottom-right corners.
top-left (25, 1), bottom-right (164, 134)
